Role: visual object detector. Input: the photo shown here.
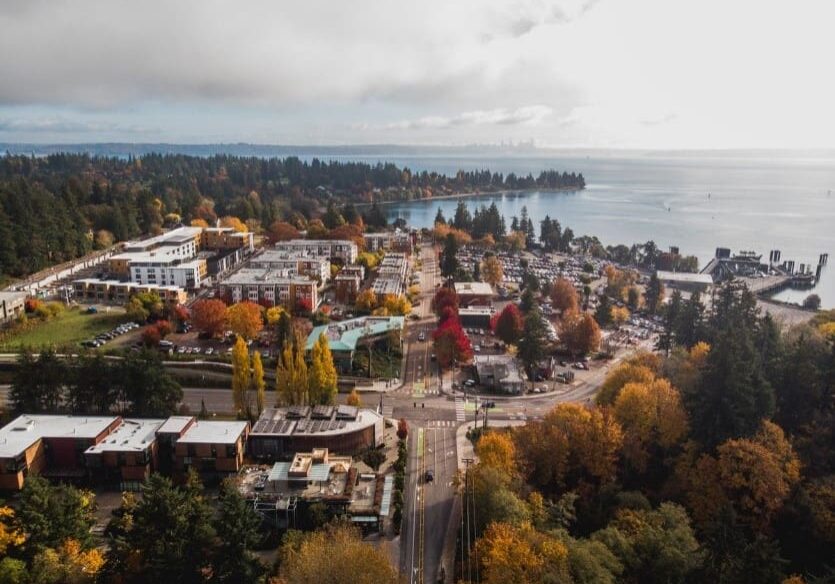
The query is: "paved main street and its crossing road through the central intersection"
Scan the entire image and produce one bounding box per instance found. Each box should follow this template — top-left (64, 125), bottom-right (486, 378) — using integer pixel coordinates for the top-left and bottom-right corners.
top-left (0, 238), bottom-right (644, 584)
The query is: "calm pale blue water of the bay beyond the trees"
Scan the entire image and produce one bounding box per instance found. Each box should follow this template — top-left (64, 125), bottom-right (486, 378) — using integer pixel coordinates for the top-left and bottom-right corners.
top-left (324, 156), bottom-right (835, 307)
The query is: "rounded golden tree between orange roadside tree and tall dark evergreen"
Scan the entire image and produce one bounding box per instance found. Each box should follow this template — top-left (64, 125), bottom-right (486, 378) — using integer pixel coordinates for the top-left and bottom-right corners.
top-left (614, 379), bottom-right (687, 472)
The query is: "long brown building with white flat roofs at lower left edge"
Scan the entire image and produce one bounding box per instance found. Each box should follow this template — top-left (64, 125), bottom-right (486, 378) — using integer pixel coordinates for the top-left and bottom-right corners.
top-left (0, 414), bottom-right (249, 491)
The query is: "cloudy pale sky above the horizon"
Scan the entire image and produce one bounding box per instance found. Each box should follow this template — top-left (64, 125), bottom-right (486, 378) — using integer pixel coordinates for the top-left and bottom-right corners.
top-left (0, 0), bottom-right (835, 149)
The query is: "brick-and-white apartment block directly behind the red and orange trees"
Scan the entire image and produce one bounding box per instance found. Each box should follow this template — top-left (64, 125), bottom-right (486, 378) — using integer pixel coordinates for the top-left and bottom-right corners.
top-left (218, 268), bottom-right (319, 310)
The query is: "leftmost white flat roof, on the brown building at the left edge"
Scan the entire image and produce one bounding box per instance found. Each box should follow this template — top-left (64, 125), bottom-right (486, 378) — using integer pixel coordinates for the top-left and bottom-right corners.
top-left (0, 414), bottom-right (118, 458)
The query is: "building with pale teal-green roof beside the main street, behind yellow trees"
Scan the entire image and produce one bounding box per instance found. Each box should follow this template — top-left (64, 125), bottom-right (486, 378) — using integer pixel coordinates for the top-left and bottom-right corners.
top-left (306, 316), bottom-right (406, 373)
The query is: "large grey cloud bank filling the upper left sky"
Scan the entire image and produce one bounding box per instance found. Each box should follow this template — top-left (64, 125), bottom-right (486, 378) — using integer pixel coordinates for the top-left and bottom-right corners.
top-left (0, 0), bottom-right (589, 109)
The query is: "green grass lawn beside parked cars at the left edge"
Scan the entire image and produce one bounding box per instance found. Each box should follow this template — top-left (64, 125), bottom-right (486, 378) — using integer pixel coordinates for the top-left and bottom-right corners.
top-left (0, 308), bottom-right (127, 351)
